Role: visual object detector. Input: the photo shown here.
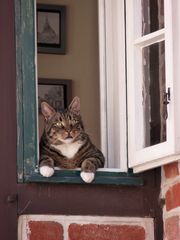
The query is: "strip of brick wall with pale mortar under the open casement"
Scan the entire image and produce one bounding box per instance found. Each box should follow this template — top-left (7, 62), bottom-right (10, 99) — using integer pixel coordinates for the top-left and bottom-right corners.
top-left (162, 162), bottom-right (180, 240)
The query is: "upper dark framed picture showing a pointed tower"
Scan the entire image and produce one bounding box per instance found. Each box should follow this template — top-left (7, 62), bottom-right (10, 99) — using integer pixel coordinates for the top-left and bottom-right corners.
top-left (37, 4), bottom-right (66, 54)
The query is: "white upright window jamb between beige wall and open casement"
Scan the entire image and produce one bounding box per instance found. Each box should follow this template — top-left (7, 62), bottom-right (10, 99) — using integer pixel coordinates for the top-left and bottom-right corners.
top-left (98, 0), bottom-right (127, 172)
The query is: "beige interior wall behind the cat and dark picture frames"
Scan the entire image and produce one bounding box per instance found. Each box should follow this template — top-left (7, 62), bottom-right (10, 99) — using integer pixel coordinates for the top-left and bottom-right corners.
top-left (37, 0), bottom-right (100, 147)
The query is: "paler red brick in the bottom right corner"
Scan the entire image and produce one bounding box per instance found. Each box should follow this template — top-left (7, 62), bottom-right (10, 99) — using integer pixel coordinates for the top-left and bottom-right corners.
top-left (164, 216), bottom-right (180, 240)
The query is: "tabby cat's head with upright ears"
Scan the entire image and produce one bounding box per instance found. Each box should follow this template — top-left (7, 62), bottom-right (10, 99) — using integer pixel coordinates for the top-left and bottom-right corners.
top-left (41, 98), bottom-right (83, 145)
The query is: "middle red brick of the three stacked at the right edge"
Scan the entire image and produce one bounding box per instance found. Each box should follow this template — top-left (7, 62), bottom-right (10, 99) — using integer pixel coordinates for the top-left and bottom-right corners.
top-left (165, 183), bottom-right (180, 211)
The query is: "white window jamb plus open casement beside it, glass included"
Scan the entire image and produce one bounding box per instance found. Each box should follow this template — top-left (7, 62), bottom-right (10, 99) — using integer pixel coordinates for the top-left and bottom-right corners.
top-left (99, 0), bottom-right (180, 172)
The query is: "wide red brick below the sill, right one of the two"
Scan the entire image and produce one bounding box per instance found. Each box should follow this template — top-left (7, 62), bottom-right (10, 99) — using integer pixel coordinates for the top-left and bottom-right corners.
top-left (68, 223), bottom-right (145, 240)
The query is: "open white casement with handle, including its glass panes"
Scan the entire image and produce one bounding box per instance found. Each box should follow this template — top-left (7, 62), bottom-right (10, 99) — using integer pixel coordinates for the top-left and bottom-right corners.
top-left (126, 0), bottom-right (180, 171)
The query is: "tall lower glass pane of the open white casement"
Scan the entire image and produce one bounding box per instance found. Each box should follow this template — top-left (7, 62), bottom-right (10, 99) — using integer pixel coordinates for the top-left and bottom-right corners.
top-left (136, 41), bottom-right (167, 148)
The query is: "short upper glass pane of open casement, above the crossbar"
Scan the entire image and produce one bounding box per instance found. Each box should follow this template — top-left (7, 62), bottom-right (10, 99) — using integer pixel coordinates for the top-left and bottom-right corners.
top-left (141, 0), bottom-right (164, 36)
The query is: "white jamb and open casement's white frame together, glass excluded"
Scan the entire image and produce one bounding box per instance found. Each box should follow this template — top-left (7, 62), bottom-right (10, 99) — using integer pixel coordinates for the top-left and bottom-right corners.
top-left (98, 0), bottom-right (180, 172)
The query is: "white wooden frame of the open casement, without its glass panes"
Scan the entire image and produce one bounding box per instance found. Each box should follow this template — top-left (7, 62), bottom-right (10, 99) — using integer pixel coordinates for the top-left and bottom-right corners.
top-left (126, 0), bottom-right (180, 172)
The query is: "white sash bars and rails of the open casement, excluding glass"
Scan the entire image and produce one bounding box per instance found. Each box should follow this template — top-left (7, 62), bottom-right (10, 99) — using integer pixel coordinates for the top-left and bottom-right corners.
top-left (126, 0), bottom-right (178, 172)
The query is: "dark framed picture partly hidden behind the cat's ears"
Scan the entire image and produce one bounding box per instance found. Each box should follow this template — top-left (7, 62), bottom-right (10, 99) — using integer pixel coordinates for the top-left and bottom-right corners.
top-left (38, 78), bottom-right (72, 114)
